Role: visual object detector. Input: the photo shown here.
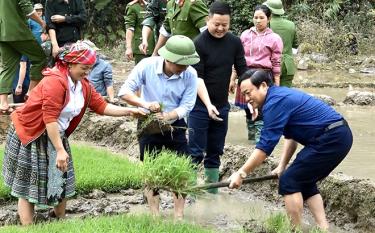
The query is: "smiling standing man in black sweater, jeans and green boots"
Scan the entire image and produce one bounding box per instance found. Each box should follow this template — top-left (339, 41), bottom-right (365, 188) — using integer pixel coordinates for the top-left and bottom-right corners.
top-left (188, 1), bottom-right (247, 193)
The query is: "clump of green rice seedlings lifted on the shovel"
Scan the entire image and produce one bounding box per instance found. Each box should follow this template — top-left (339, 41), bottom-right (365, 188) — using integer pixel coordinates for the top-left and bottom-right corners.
top-left (141, 150), bottom-right (197, 195)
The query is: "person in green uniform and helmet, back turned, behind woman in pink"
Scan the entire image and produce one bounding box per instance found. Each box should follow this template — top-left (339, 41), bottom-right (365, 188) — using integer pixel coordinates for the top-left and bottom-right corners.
top-left (263, 0), bottom-right (298, 87)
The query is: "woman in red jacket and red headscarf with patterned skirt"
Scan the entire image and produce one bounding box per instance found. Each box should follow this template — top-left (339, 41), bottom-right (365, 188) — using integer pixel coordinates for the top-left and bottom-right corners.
top-left (3, 42), bottom-right (144, 225)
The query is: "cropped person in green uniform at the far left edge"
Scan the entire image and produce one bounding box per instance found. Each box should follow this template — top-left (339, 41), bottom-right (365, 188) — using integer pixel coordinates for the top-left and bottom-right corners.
top-left (0, 0), bottom-right (46, 114)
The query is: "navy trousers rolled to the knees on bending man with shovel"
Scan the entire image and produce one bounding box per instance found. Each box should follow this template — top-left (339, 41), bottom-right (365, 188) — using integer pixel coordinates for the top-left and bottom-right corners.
top-left (279, 122), bottom-right (353, 200)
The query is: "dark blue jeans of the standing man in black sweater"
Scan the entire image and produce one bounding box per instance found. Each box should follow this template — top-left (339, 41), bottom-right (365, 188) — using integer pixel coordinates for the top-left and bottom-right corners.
top-left (188, 102), bottom-right (230, 168)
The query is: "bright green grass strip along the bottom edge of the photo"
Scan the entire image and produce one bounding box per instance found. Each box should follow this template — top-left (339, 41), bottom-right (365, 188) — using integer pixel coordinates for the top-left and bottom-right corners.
top-left (1, 215), bottom-right (213, 233)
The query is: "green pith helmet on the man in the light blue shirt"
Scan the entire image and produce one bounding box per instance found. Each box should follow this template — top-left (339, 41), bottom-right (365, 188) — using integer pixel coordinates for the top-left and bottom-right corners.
top-left (159, 35), bottom-right (200, 65)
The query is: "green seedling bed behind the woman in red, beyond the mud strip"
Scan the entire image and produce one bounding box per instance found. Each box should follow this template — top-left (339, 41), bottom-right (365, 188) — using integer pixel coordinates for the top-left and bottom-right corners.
top-left (0, 145), bottom-right (142, 201)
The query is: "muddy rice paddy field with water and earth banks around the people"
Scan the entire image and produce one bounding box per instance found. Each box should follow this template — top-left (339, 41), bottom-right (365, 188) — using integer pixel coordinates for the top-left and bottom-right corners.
top-left (0, 62), bottom-right (375, 233)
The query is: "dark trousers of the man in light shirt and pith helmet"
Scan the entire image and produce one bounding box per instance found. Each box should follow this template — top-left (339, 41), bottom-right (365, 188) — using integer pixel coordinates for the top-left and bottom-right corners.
top-left (139, 119), bottom-right (189, 161)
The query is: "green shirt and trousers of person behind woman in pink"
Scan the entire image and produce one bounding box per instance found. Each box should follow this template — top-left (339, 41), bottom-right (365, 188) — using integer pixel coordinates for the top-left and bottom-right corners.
top-left (270, 15), bottom-right (298, 75)
